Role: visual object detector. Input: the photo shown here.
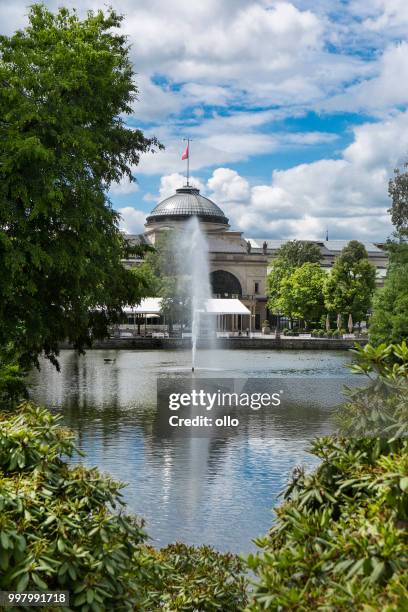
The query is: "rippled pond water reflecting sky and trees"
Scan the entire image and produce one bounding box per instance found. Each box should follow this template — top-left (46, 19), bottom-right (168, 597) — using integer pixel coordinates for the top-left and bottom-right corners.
top-left (31, 350), bottom-right (354, 552)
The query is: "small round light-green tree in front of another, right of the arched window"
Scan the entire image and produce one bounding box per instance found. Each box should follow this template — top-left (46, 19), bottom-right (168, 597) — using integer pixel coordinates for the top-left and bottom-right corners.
top-left (277, 263), bottom-right (326, 326)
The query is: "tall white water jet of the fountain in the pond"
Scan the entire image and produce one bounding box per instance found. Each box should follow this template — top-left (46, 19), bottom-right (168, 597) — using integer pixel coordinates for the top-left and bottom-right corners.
top-left (179, 217), bottom-right (215, 372)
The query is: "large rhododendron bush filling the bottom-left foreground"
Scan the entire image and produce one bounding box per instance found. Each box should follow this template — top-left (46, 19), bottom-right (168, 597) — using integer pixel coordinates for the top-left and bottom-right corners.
top-left (0, 403), bottom-right (146, 612)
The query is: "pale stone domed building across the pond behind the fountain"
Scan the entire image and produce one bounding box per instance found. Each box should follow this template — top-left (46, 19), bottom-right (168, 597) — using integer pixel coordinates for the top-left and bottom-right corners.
top-left (128, 184), bottom-right (387, 331)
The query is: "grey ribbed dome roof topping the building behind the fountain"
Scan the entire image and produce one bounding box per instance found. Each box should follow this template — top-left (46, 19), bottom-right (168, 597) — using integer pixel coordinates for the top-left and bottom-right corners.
top-left (146, 185), bottom-right (228, 225)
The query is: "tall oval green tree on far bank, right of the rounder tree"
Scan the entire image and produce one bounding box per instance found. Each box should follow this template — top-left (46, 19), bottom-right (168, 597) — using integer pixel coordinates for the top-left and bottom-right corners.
top-left (324, 240), bottom-right (376, 322)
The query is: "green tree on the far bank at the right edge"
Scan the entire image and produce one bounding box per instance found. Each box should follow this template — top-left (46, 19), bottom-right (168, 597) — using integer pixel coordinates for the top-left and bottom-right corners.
top-left (369, 240), bottom-right (408, 344)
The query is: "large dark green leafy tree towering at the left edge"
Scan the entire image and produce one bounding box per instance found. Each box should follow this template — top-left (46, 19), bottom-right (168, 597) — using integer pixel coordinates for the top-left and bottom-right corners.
top-left (0, 5), bottom-right (160, 365)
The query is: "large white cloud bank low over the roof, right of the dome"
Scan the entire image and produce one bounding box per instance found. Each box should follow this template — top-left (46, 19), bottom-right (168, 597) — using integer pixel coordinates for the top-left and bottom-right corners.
top-left (204, 111), bottom-right (408, 240)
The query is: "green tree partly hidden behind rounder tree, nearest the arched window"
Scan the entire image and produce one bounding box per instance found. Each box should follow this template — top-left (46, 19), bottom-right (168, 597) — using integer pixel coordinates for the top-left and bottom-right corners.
top-left (267, 240), bottom-right (321, 316)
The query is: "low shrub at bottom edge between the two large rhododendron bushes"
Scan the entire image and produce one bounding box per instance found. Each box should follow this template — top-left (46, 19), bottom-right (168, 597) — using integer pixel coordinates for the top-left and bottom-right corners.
top-left (135, 543), bottom-right (247, 612)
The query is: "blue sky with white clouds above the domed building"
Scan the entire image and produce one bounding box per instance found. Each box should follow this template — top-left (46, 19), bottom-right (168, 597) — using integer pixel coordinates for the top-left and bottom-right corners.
top-left (0, 0), bottom-right (408, 241)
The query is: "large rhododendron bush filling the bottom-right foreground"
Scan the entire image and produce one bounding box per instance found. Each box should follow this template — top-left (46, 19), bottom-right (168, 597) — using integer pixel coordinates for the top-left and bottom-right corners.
top-left (248, 344), bottom-right (408, 612)
